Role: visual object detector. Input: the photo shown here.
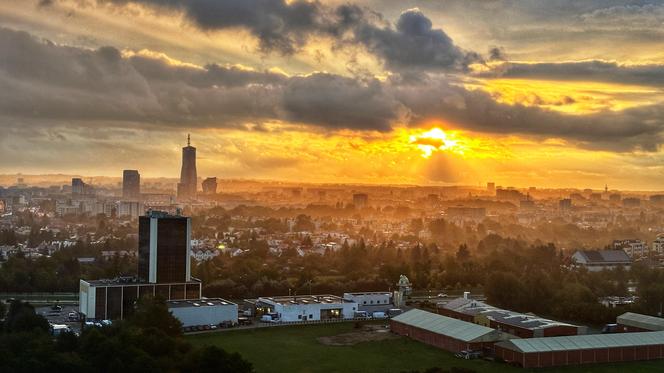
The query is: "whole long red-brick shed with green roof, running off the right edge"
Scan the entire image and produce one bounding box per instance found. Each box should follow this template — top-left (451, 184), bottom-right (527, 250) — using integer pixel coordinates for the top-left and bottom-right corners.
top-left (495, 332), bottom-right (664, 368)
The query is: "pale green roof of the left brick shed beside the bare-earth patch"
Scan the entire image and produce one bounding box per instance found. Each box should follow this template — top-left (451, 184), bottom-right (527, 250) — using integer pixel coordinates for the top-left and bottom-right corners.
top-left (392, 309), bottom-right (511, 342)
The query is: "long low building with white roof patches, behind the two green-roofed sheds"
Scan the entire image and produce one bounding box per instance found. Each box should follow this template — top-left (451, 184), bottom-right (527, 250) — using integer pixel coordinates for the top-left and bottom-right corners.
top-left (438, 297), bottom-right (586, 338)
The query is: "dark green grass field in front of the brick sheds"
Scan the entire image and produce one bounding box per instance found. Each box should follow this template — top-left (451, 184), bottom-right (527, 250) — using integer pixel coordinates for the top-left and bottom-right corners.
top-left (187, 323), bottom-right (664, 373)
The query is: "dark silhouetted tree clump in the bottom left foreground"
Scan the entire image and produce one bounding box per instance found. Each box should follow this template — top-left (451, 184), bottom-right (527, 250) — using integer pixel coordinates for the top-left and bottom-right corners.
top-left (0, 300), bottom-right (252, 373)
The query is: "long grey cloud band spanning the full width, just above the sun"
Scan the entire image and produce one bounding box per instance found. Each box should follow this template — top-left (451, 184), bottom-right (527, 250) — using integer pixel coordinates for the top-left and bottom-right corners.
top-left (0, 29), bottom-right (664, 151)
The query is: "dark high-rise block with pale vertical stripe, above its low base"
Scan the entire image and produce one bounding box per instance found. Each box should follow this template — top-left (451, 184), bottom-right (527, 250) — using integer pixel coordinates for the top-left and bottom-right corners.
top-left (138, 211), bottom-right (191, 283)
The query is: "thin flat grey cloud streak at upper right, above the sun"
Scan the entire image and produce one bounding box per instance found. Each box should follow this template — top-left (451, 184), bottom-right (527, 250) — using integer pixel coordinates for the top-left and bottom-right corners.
top-left (481, 61), bottom-right (664, 87)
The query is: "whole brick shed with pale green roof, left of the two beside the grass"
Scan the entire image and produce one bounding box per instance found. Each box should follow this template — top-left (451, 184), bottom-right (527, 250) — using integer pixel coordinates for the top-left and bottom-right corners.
top-left (390, 309), bottom-right (514, 352)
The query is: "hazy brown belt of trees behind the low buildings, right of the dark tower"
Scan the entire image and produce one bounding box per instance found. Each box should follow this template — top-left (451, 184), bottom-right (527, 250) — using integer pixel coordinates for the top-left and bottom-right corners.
top-left (194, 234), bottom-right (664, 324)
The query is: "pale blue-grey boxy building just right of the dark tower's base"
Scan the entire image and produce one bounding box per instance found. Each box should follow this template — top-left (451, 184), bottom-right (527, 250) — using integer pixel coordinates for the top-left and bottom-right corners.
top-left (167, 298), bottom-right (238, 328)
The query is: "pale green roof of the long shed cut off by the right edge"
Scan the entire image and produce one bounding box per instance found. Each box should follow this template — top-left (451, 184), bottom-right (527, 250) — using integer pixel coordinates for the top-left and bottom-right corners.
top-left (496, 332), bottom-right (664, 353)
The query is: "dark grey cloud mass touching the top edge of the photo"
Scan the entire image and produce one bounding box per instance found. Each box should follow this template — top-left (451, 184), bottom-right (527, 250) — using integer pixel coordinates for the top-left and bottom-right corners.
top-left (100, 0), bottom-right (482, 71)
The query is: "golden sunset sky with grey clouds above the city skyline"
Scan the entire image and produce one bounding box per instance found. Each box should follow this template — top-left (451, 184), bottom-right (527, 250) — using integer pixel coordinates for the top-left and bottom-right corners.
top-left (0, 0), bottom-right (664, 190)
